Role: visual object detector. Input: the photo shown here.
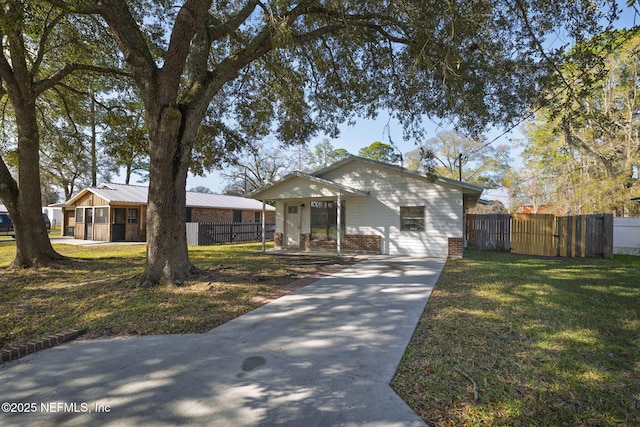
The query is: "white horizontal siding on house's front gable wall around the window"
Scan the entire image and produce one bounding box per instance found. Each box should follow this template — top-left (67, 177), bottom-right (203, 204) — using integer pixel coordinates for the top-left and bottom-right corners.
top-left (321, 161), bottom-right (463, 257)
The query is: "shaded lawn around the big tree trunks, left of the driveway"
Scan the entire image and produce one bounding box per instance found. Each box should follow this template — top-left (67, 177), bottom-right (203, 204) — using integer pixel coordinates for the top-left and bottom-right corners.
top-left (0, 242), bottom-right (353, 348)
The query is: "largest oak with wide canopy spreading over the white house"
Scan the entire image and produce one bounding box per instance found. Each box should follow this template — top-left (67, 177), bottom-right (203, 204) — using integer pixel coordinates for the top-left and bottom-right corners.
top-left (51, 0), bottom-right (616, 284)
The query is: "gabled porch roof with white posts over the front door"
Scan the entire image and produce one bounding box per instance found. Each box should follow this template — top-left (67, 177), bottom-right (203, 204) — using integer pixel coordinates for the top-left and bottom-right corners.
top-left (247, 172), bottom-right (369, 255)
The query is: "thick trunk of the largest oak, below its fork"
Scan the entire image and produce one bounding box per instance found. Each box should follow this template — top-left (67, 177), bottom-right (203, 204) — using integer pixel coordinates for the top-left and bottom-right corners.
top-left (135, 106), bottom-right (197, 286)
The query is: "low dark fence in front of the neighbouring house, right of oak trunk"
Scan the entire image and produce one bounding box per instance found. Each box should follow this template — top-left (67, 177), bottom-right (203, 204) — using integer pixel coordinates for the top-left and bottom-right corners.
top-left (187, 222), bottom-right (276, 246)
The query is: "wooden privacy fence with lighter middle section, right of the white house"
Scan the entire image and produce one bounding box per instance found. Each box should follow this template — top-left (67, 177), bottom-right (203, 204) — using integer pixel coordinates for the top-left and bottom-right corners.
top-left (466, 214), bottom-right (613, 258)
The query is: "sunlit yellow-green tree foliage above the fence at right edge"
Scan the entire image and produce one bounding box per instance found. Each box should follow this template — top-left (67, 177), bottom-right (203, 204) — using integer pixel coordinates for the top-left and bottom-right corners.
top-left (518, 28), bottom-right (640, 215)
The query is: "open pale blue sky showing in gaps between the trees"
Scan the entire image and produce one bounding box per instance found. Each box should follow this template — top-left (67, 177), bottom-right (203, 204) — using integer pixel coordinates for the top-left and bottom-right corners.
top-left (122, 1), bottom-right (640, 205)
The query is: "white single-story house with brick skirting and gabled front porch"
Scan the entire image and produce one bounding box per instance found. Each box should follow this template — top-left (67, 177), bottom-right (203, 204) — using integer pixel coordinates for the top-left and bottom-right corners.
top-left (249, 156), bottom-right (483, 257)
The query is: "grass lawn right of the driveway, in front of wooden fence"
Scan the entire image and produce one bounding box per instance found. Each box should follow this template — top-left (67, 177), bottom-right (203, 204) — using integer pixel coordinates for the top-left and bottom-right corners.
top-left (392, 251), bottom-right (640, 426)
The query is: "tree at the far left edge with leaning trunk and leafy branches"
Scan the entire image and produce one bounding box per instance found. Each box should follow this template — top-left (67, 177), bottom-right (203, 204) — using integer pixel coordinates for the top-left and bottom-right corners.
top-left (0, 0), bottom-right (121, 267)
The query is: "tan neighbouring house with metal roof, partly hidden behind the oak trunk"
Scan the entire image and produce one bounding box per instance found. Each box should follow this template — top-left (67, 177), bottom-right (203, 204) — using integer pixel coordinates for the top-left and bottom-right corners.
top-left (63, 184), bottom-right (275, 242)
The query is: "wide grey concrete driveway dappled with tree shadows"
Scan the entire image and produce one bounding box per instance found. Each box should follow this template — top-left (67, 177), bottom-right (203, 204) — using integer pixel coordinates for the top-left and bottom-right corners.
top-left (0, 257), bottom-right (444, 426)
